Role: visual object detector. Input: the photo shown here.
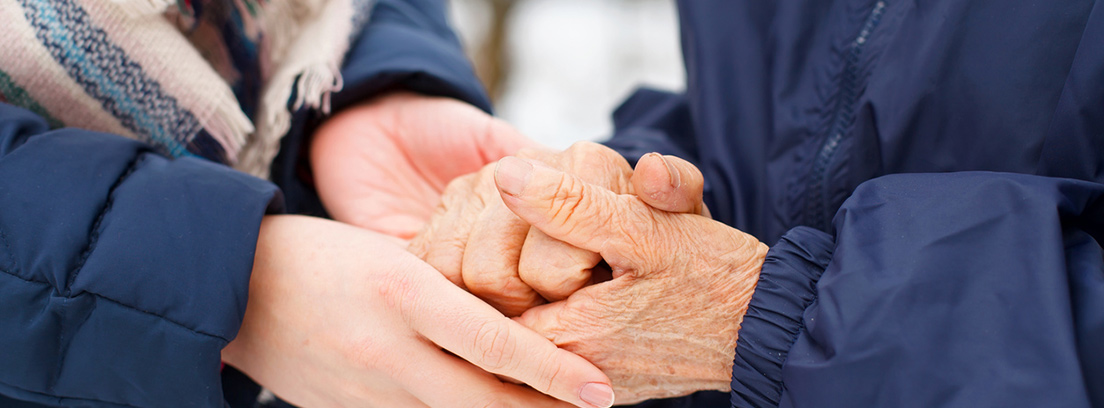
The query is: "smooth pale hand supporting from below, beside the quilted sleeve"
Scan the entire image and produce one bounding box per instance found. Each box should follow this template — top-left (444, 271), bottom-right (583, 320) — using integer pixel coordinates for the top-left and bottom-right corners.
top-left (222, 216), bottom-right (613, 407)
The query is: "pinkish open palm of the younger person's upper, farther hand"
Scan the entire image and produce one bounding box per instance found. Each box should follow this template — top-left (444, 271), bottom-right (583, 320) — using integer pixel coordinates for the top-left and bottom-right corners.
top-left (311, 94), bottom-right (532, 239)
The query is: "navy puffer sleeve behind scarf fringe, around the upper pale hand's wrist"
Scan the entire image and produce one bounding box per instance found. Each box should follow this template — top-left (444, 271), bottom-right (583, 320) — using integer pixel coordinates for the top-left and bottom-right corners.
top-left (272, 0), bottom-right (491, 216)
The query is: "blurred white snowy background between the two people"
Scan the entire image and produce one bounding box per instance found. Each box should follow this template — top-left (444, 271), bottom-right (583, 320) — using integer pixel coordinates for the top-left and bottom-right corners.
top-left (450, 0), bottom-right (684, 148)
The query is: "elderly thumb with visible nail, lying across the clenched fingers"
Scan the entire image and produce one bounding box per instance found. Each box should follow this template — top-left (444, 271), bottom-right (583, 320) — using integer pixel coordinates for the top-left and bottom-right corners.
top-left (495, 157), bottom-right (652, 258)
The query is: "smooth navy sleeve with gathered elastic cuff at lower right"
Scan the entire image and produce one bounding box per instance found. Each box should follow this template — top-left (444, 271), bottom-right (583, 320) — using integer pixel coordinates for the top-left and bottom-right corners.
top-left (731, 172), bottom-right (1104, 408)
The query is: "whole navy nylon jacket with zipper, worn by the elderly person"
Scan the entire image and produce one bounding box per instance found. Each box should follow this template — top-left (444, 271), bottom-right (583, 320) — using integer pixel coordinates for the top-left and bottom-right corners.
top-left (608, 0), bottom-right (1104, 407)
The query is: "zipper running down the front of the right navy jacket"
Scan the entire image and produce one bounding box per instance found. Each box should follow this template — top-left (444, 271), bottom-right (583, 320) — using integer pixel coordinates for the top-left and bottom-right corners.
top-left (805, 1), bottom-right (885, 232)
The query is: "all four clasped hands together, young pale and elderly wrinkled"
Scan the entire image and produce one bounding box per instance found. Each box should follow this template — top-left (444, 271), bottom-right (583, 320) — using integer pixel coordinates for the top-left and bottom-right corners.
top-left (223, 93), bottom-right (767, 407)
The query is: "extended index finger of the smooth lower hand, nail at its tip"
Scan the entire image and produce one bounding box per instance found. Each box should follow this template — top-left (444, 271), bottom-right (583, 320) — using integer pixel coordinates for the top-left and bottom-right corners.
top-left (402, 273), bottom-right (613, 407)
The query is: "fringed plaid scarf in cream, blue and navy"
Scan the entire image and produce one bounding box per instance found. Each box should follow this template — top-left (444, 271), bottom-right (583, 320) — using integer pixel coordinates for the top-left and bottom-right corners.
top-left (0, 0), bottom-right (372, 178)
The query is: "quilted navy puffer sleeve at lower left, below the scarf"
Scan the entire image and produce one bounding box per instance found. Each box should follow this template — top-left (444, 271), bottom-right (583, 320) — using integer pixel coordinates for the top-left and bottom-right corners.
top-left (0, 104), bottom-right (279, 407)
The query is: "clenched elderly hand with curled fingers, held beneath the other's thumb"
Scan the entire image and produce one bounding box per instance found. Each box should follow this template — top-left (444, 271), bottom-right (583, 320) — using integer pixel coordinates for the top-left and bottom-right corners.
top-left (410, 142), bottom-right (705, 315)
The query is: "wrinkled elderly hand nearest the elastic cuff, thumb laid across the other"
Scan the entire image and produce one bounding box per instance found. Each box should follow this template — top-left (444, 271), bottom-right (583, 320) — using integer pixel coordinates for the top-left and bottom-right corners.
top-left (495, 157), bottom-right (767, 404)
